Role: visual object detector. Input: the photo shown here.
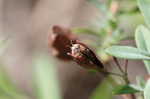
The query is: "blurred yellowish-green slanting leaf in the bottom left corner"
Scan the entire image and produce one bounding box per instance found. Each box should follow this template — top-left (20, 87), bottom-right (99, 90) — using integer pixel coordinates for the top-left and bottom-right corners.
top-left (0, 67), bottom-right (29, 99)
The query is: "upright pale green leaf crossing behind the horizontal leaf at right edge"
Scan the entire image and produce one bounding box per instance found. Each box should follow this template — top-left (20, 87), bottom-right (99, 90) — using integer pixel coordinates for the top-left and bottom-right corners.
top-left (135, 25), bottom-right (150, 73)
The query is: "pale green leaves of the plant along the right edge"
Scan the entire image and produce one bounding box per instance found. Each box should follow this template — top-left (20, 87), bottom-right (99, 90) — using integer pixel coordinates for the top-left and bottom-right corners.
top-left (105, 0), bottom-right (150, 99)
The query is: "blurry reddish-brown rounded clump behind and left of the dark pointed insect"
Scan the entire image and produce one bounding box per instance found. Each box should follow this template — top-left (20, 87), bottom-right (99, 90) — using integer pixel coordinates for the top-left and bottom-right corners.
top-left (48, 25), bottom-right (77, 61)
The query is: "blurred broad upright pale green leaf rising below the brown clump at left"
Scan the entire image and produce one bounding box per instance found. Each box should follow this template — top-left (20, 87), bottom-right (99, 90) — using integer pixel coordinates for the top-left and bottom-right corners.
top-left (34, 56), bottom-right (61, 99)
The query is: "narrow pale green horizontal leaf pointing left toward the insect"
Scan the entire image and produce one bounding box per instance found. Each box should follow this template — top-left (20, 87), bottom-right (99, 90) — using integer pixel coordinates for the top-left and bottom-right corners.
top-left (105, 46), bottom-right (150, 60)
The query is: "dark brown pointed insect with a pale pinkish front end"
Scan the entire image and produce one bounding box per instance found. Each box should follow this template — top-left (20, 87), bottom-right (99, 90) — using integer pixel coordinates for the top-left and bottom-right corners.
top-left (67, 40), bottom-right (104, 69)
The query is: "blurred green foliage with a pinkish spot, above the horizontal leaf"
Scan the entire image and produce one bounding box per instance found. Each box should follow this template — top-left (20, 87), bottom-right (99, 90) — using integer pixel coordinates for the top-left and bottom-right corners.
top-left (72, 0), bottom-right (144, 63)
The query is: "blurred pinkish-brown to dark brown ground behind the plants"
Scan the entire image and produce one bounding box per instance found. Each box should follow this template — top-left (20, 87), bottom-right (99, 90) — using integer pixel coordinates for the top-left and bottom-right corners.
top-left (0, 0), bottom-right (146, 99)
